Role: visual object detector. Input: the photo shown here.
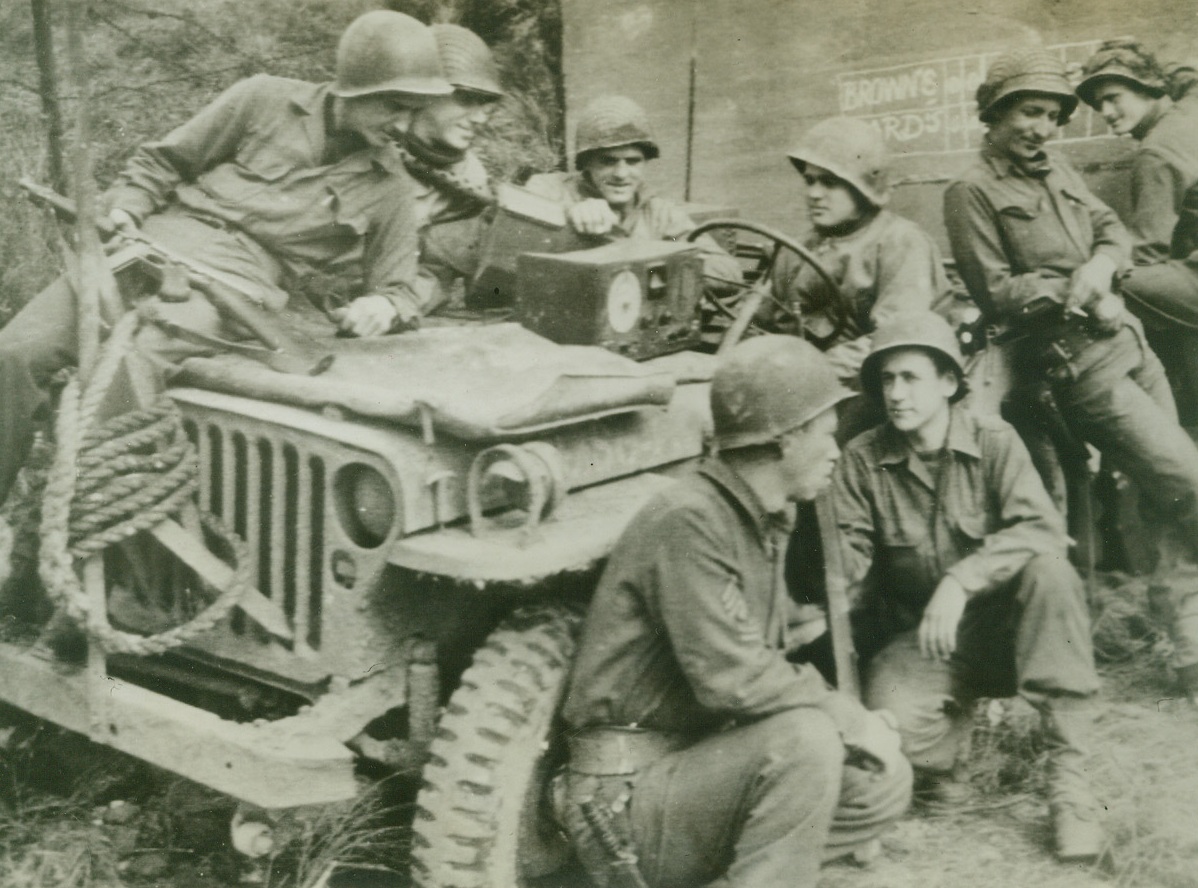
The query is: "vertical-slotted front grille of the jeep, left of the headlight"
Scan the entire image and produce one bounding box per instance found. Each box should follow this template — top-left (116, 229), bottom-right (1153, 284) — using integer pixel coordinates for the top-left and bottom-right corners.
top-left (186, 421), bottom-right (326, 652)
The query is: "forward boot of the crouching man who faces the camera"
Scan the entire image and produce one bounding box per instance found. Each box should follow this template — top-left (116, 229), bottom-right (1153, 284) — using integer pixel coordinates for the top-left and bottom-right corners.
top-left (1034, 696), bottom-right (1106, 863)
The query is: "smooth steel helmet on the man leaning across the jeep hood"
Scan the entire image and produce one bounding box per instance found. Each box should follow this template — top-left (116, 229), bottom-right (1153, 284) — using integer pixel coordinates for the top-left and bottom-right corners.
top-left (332, 10), bottom-right (453, 103)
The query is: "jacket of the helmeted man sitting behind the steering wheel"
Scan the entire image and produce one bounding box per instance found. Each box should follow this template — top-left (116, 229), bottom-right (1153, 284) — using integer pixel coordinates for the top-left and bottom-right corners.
top-left (774, 210), bottom-right (949, 387)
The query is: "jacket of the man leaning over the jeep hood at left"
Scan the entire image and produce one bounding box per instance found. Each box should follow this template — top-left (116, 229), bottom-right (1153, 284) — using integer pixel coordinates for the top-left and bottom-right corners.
top-left (107, 74), bottom-right (429, 313)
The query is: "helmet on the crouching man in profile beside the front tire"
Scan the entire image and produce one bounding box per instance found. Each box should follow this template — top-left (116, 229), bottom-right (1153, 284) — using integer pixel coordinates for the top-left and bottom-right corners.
top-left (712, 333), bottom-right (853, 451)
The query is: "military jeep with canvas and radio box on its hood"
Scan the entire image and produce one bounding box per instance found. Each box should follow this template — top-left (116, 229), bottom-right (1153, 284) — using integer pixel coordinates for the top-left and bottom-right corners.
top-left (0, 210), bottom-right (795, 886)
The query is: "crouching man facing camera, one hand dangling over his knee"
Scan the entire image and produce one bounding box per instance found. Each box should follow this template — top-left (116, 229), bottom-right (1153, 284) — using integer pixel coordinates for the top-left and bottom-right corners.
top-left (834, 312), bottom-right (1103, 860)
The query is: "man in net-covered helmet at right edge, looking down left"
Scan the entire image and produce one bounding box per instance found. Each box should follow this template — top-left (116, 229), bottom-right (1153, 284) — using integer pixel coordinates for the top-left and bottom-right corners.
top-left (1077, 40), bottom-right (1198, 425)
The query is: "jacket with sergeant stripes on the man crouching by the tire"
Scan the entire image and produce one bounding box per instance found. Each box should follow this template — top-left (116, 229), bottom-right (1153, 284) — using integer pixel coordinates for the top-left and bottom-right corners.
top-left (564, 459), bottom-right (860, 736)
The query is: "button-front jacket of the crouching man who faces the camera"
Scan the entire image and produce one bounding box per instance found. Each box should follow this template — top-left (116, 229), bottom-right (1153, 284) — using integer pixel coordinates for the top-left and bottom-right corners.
top-left (833, 407), bottom-right (1069, 630)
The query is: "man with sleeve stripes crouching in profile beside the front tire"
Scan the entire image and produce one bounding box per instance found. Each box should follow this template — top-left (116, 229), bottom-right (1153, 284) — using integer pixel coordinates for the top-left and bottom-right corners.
top-left (557, 336), bottom-right (910, 888)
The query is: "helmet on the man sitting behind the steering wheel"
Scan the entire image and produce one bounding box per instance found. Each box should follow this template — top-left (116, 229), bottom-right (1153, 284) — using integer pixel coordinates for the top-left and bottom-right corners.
top-left (787, 117), bottom-right (890, 207)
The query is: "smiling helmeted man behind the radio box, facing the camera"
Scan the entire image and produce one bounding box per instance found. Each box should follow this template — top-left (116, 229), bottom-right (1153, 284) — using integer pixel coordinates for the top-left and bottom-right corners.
top-left (526, 96), bottom-right (740, 282)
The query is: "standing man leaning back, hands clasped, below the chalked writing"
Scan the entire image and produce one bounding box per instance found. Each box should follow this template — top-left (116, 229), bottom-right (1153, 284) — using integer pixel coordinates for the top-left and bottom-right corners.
top-left (944, 49), bottom-right (1198, 697)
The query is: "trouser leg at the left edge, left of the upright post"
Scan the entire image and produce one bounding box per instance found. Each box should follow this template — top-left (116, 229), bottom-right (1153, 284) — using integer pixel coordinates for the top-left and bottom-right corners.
top-left (0, 278), bottom-right (77, 503)
